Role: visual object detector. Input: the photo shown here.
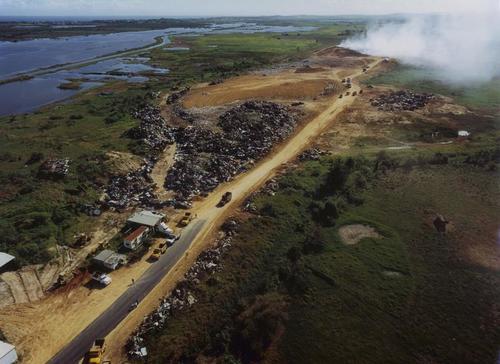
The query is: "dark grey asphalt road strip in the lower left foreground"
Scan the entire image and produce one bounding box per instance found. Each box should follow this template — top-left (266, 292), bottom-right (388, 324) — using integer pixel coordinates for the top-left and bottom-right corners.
top-left (49, 220), bottom-right (206, 364)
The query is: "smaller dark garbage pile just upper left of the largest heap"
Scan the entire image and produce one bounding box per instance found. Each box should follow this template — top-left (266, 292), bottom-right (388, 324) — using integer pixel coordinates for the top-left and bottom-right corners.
top-left (127, 105), bottom-right (174, 151)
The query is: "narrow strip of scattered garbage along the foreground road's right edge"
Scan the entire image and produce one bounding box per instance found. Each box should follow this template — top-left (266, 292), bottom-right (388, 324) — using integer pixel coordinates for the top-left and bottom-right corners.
top-left (126, 228), bottom-right (232, 359)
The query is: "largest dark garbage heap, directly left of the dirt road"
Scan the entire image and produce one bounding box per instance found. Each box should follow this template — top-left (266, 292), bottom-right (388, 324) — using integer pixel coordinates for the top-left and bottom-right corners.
top-left (165, 101), bottom-right (296, 202)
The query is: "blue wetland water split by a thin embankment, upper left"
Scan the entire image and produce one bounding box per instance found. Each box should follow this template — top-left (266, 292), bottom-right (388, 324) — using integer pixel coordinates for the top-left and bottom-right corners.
top-left (0, 23), bottom-right (315, 116)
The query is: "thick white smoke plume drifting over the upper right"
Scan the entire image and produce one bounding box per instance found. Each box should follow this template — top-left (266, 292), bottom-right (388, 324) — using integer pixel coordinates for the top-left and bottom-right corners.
top-left (342, 7), bottom-right (500, 83)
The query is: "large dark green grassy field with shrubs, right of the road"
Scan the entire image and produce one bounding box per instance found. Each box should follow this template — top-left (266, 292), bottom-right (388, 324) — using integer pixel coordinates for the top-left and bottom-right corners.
top-left (143, 155), bottom-right (500, 363)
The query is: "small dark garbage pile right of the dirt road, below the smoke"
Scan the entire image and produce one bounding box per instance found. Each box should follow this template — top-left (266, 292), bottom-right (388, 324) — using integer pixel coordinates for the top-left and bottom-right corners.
top-left (370, 90), bottom-right (434, 111)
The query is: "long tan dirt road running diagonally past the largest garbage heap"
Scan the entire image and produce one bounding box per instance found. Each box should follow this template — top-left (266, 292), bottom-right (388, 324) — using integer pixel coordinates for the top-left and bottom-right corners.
top-left (103, 60), bottom-right (380, 363)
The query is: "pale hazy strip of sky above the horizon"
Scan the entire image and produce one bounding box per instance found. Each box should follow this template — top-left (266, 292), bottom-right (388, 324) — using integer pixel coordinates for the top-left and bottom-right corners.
top-left (0, 0), bottom-right (500, 17)
